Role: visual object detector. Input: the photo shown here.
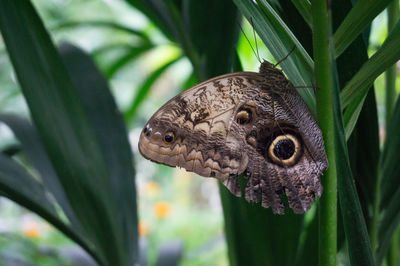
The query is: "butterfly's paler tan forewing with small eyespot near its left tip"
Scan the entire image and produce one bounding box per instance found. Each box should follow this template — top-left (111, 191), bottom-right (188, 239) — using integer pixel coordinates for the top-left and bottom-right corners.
top-left (139, 72), bottom-right (261, 183)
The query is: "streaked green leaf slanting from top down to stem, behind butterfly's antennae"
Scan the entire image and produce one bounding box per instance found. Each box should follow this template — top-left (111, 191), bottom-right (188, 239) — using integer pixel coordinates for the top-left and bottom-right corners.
top-left (234, 0), bottom-right (315, 114)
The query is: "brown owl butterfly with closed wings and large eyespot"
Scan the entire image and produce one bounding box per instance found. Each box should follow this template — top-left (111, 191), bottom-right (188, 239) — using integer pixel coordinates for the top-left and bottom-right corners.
top-left (139, 61), bottom-right (328, 214)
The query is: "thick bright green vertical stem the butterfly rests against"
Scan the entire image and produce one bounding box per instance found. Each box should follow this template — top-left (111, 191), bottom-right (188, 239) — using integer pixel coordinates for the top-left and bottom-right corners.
top-left (311, 0), bottom-right (337, 266)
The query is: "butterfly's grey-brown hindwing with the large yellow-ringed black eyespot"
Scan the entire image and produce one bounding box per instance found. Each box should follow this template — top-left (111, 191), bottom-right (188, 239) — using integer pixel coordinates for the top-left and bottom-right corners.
top-left (234, 87), bottom-right (328, 214)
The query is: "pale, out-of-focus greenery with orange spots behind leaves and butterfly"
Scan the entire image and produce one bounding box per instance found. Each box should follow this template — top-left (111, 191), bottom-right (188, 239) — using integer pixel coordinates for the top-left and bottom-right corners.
top-left (0, 0), bottom-right (400, 265)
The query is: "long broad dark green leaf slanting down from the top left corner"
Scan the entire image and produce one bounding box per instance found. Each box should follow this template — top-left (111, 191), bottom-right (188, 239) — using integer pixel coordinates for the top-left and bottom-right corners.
top-left (0, 0), bottom-right (137, 265)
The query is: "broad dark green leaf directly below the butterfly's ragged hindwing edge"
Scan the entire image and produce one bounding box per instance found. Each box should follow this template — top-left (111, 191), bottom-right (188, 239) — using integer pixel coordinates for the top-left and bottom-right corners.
top-left (220, 184), bottom-right (304, 266)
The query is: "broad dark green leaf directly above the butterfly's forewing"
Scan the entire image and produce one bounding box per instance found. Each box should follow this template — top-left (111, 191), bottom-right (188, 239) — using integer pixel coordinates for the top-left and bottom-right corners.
top-left (181, 0), bottom-right (240, 80)
